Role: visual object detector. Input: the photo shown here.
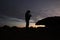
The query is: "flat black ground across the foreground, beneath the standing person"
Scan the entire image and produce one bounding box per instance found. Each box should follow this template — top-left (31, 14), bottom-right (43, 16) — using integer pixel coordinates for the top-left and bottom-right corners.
top-left (0, 25), bottom-right (59, 40)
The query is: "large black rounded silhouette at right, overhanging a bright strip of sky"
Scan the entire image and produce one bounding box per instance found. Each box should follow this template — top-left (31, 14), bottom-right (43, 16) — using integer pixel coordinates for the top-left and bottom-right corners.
top-left (36, 16), bottom-right (60, 29)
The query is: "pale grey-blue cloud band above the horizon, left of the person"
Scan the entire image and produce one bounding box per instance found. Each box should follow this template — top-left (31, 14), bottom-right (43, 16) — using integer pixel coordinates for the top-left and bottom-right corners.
top-left (0, 15), bottom-right (25, 26)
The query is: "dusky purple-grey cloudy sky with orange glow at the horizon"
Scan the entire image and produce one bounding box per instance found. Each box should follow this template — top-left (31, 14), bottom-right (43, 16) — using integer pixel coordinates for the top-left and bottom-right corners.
top-left (0, 0), bottom-right (60, 27)
